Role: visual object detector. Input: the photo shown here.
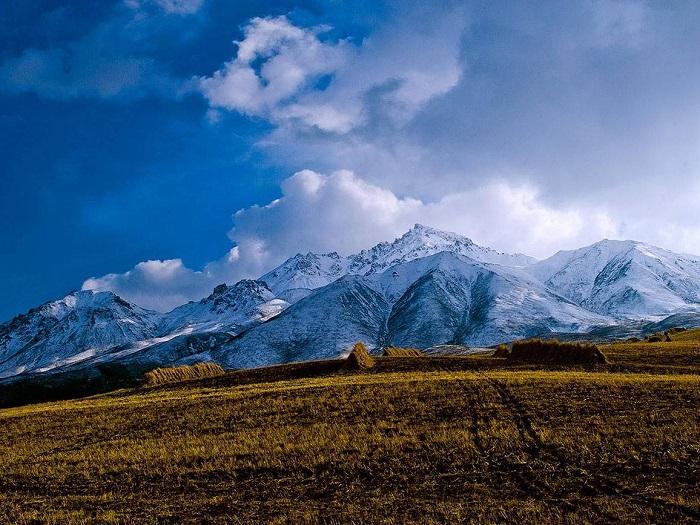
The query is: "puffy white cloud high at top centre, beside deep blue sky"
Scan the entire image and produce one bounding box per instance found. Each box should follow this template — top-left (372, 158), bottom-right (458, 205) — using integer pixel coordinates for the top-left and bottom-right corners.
top-left (199, 10), bottom-right (465, 135)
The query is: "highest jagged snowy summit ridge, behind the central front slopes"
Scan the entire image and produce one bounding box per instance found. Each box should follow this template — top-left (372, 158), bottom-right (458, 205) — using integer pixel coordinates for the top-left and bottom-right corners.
top-left (260, 224), bottom-right (536, 296)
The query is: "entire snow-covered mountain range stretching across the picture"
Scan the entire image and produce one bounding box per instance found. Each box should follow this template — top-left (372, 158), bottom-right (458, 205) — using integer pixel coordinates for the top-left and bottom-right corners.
top-left (0, 224), bottom-right (700, 381)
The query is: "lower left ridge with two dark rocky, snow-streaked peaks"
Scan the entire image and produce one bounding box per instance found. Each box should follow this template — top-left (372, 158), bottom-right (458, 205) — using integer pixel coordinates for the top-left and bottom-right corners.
top-left (0, 280), bottom-right (289, 378)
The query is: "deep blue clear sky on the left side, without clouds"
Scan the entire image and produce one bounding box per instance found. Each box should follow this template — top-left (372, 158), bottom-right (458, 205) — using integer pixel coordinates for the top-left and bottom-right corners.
top-left (0, 1), bottom-right (370, 319)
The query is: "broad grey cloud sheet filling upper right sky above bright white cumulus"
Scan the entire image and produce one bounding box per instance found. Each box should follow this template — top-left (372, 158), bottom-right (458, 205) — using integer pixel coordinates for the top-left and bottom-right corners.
top-left (250, 0), bottom-right (700, 221)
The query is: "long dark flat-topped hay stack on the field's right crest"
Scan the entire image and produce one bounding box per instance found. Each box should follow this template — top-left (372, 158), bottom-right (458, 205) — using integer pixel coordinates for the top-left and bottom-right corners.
top-left (508, 339), bottom-right (608, 365)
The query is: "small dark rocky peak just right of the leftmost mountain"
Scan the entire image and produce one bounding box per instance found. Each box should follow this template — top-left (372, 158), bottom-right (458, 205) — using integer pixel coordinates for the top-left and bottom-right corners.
top-left (160, 279), bottom-right (289, 334)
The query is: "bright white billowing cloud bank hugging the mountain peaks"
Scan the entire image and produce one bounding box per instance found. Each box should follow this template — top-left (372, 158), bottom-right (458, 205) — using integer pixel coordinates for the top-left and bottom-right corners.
top-left (83, 170), bottom-right (612, 311)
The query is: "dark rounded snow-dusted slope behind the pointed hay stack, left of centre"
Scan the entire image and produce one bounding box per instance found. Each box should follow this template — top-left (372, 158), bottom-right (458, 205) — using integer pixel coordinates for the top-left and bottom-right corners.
top-left (213, 275), bottom-right (389, 368)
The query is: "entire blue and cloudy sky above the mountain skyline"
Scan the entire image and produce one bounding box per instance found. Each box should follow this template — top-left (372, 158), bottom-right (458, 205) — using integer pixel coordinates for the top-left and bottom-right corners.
top-left (0, 0), bottom-right (700, 320)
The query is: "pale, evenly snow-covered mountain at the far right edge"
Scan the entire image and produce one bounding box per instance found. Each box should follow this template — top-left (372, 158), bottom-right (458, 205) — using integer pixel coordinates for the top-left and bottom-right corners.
top-left (528, 240), bottom-right (700, 318)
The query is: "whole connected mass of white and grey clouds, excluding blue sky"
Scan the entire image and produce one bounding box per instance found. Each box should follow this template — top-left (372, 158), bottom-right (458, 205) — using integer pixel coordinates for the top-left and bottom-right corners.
top-left (79, 0), bottom-right (700, 309)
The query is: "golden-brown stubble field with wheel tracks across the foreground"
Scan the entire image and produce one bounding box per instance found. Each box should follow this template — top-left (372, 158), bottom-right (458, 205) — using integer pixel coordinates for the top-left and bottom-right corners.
top-left (0, 331), bottom-right (700, 524)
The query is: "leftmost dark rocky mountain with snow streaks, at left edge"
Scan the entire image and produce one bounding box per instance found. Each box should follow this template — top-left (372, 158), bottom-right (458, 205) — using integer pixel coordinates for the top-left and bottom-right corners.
top-left (0, 291), bottom-right (161, 378)
